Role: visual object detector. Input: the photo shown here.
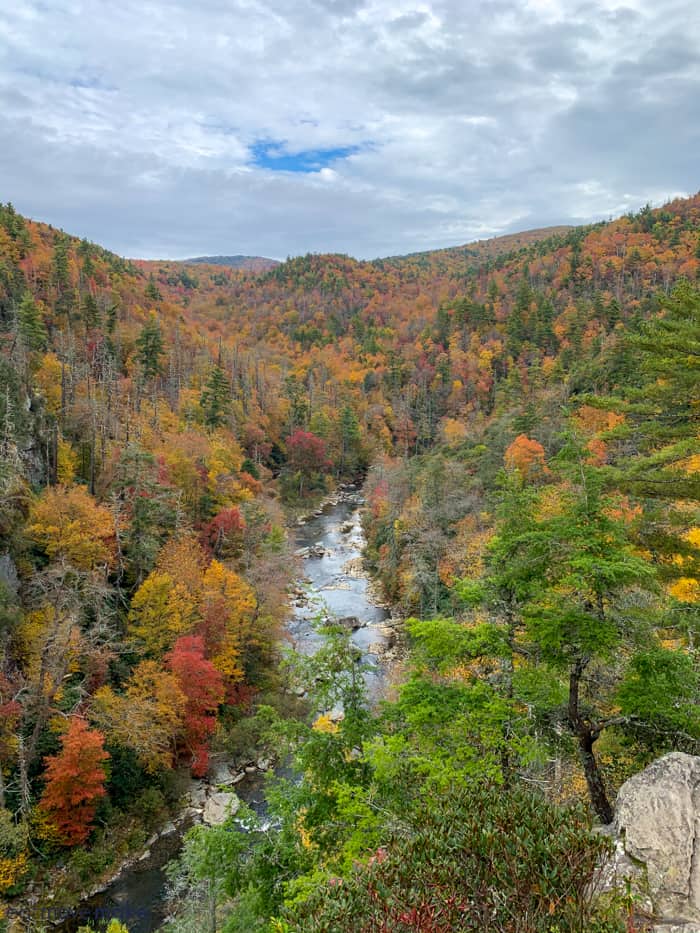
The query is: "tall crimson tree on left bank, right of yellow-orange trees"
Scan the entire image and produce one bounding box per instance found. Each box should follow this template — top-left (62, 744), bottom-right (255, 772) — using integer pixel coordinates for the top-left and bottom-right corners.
top-left (167, 635), bottom-right (225, 777)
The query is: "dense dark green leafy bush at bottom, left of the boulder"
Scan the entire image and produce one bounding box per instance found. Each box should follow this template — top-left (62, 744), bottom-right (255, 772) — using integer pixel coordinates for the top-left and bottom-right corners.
top-left (282, 787), bottom-right (618, 933)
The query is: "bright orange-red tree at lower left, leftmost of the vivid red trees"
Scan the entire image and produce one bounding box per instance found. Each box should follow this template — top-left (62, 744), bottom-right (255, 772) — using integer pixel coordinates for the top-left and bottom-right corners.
top-left (40, 716), bottom-right (109, 846)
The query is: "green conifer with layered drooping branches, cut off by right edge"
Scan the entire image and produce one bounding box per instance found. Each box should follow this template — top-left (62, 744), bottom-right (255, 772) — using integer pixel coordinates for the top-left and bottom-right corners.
top-left (587, 281), bottom-right (700, 592)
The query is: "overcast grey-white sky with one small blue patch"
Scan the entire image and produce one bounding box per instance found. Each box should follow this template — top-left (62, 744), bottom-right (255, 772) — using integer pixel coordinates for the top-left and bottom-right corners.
top-left (0, 0), bottom-right (700, 259)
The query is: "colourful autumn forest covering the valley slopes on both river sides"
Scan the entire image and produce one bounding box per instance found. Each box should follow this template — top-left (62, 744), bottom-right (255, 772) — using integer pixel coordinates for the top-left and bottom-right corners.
top-left (0, 195), bottom-right (700, 933)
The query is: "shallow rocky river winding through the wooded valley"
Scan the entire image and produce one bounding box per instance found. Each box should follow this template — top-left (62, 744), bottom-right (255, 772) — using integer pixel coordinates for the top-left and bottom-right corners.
top-left (54, 488), bottom-right (393, 933)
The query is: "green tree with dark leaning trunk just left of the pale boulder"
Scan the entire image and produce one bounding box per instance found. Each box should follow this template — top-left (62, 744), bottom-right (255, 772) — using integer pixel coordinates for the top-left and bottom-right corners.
top-left (520, 451), bottom-right (654, 823)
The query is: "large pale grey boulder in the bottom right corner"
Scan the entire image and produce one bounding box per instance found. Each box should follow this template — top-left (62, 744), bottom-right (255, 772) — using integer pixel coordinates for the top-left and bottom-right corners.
top-left (613, 752), bottom-right (700, 933)
